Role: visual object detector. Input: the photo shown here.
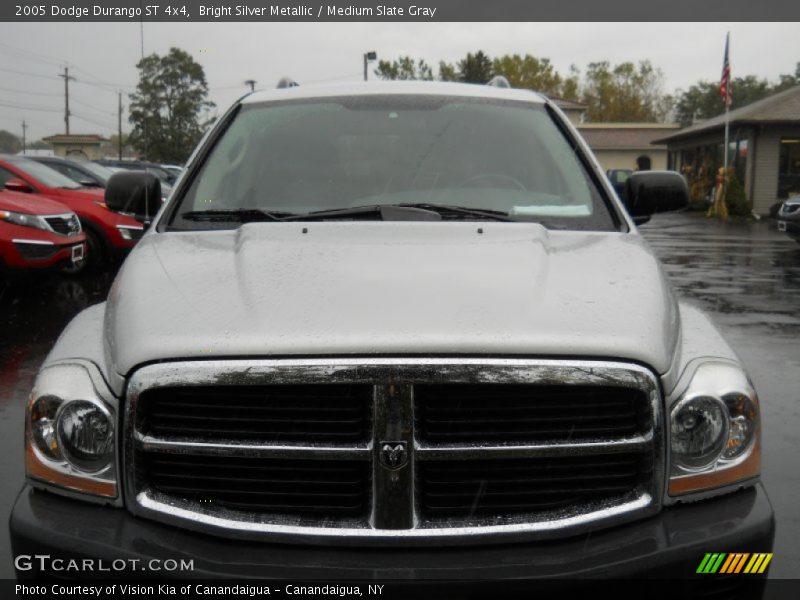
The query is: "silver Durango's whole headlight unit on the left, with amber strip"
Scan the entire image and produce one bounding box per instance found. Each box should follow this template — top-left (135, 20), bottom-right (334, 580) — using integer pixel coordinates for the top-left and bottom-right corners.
top-left (25, 364), bottom-right (118, 498)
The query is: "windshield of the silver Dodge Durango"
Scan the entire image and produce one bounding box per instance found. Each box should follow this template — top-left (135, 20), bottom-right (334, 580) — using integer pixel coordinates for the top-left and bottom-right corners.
top-left (170, 95), bottom-right (616, 230)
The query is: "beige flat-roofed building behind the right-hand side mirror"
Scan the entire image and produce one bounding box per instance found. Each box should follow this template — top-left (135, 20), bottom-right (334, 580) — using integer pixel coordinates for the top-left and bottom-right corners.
top-left (577, 123), bottom-right (679, 171)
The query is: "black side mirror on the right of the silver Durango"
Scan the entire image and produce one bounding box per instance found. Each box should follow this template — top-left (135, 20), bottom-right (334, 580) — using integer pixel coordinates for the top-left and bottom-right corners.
top-left (622, 171), bottom-right (689, 224)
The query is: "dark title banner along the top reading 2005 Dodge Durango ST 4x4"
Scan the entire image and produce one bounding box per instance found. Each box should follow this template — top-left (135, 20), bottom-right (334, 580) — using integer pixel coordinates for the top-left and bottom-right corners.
top-left (0, 0), bottom-right (800, 22)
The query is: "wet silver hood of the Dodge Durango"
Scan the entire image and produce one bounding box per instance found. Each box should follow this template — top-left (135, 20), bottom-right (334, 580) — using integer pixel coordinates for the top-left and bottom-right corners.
top-left (105, 222), bottom-right (679, 375)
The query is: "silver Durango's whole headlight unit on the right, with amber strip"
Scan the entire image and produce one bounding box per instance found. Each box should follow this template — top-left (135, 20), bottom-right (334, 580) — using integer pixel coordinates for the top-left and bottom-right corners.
top-left (669, 362), bottom-right (761, 496)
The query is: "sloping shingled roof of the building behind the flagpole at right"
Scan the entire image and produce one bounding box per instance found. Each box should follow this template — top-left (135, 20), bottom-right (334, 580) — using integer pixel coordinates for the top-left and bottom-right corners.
top-left (656, 85), bottom-right (800, 144)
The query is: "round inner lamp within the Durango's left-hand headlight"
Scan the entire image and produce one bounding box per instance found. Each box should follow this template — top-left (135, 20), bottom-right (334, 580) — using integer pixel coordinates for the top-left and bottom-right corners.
top-left (56, 400), bottom-right (114, 472)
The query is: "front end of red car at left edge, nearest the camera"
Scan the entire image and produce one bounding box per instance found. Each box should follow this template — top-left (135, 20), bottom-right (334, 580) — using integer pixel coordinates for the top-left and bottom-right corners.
top-left (0, 191), bottom-right (86, 276)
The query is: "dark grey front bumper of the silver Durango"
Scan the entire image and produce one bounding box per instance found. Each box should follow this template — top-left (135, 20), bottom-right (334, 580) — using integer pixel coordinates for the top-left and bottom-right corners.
top-left (10, 484), bottom-right (775, 582)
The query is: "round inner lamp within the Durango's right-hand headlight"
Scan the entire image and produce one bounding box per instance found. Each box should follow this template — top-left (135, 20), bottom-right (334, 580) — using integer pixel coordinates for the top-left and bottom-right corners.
top-left (671, 396), bottom-right (729, 470)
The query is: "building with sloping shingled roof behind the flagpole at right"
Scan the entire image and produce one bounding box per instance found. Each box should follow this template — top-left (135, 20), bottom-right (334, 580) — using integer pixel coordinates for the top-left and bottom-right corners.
top-left (656, 86), bottom-right (800, 214)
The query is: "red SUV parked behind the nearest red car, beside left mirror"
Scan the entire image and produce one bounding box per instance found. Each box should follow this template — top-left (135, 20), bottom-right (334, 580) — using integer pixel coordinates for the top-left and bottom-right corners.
top-left (0, 155), bottom-right (144, 262)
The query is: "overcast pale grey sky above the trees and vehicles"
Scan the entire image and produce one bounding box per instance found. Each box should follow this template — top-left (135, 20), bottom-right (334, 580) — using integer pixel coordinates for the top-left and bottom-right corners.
top-left (0, 22), bottom-right (800, 140)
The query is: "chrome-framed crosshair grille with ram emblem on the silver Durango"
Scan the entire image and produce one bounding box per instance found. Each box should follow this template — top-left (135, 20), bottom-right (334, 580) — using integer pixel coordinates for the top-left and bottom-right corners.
top-left (123, 359), bottom-right (664, 545)
